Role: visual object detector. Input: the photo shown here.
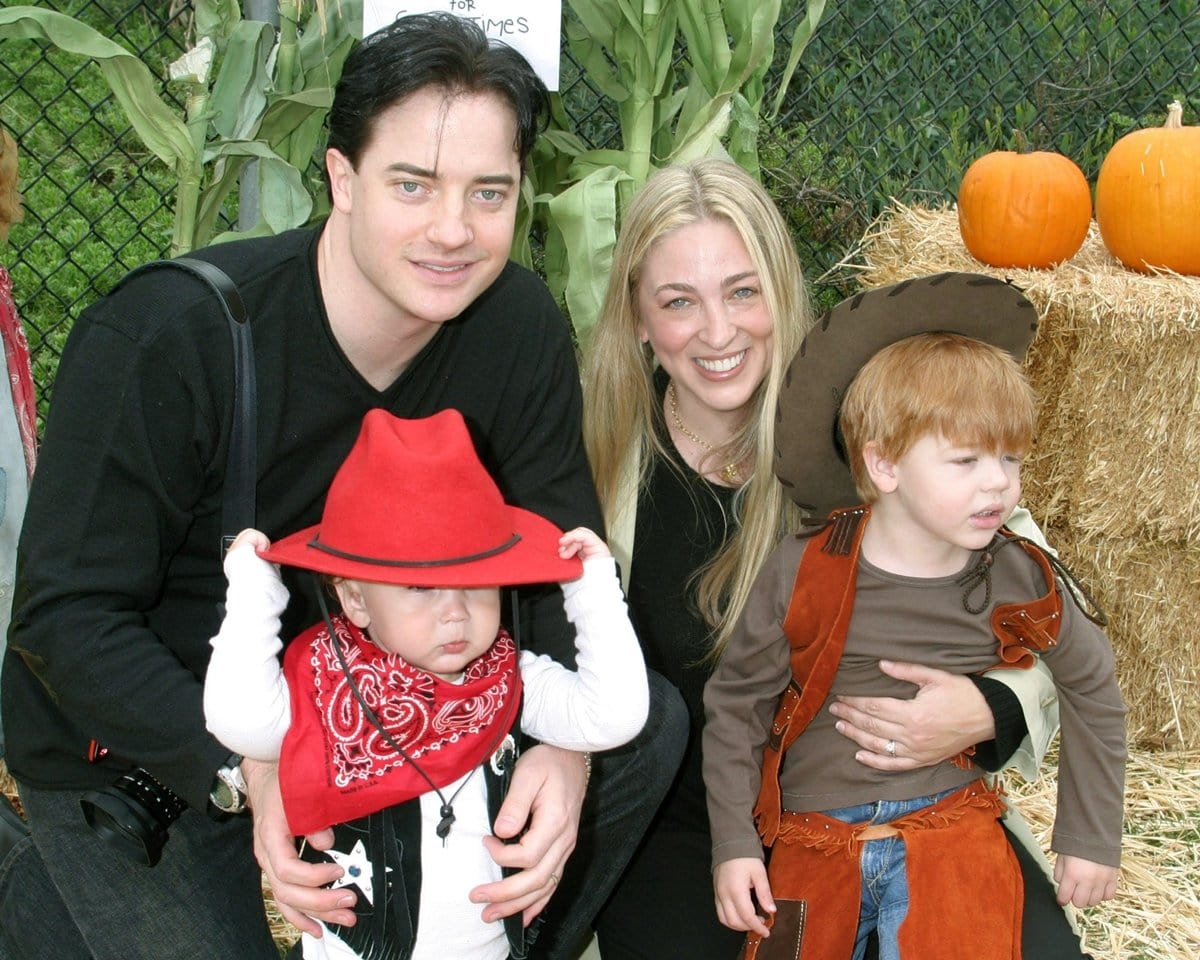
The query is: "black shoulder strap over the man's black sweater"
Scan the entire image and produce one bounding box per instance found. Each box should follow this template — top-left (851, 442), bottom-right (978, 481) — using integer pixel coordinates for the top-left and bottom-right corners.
top-left (114, 257), bottom-right (258, 556)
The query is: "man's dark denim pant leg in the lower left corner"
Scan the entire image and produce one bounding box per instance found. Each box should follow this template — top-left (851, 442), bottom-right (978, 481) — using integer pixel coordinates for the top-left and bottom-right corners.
top-left (10, 785), bottom-right (278, 960)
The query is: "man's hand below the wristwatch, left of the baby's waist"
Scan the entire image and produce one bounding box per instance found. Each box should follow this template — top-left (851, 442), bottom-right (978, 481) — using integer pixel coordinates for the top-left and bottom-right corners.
top-left (241, 758), bottom-right (355, 937)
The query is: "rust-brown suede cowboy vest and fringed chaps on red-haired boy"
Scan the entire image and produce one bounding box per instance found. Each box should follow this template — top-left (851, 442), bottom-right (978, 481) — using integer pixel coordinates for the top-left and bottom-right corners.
top-left (742, 506), bottom-right (1062, 960)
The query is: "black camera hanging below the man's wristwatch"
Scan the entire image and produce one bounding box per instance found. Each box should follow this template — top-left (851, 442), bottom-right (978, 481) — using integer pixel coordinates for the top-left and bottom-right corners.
top-left (79, 767), bottom-right (187, 866)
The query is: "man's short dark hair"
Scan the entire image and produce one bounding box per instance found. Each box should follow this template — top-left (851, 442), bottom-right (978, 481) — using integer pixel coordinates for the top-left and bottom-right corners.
top-left (329, 13), bottom-right (550, 170)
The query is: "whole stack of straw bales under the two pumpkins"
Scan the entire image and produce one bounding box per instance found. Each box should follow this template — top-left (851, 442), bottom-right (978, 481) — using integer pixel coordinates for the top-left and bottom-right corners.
top-left (841, 204), bottom-right (1200, 748)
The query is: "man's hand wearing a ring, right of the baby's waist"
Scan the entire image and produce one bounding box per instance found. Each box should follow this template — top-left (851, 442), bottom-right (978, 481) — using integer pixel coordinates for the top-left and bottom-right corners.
top-left (470, 744), bottom-right (587, 926)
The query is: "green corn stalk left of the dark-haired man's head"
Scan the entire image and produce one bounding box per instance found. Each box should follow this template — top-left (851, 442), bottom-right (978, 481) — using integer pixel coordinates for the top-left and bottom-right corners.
top-left (0, 0), bottom-right (362, 256)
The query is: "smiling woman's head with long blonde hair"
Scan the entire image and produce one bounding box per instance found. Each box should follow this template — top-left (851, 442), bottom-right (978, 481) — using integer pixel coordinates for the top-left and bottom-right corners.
top-left (583, 160), bottom-right (811, 655)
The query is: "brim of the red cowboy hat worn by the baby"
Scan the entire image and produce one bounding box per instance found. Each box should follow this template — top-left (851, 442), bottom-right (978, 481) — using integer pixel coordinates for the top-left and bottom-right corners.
top-left (260, 506), bottom-right (583, 588)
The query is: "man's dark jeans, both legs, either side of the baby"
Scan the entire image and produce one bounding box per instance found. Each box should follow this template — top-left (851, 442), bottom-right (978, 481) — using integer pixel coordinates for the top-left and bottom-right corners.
top-left (0, 673), bottom-right (688, 960)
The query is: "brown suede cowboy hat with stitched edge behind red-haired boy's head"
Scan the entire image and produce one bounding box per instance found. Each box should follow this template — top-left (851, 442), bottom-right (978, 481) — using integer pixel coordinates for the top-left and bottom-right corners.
top-left (775, 272), bottom-right (1038, 517)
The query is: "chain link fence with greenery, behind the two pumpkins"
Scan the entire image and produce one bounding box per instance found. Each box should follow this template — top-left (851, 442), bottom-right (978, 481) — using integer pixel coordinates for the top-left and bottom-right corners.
top-left (760, 0), bottom-right (1200, 304)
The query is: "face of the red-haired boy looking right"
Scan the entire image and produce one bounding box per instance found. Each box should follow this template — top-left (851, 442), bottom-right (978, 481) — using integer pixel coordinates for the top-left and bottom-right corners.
top-left (890, 434), bottom-right (1021, 559)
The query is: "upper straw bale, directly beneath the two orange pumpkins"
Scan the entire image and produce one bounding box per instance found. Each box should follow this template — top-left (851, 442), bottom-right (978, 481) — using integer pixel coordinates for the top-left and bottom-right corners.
top-left (842, 204), bottom-right (1200, 544)
